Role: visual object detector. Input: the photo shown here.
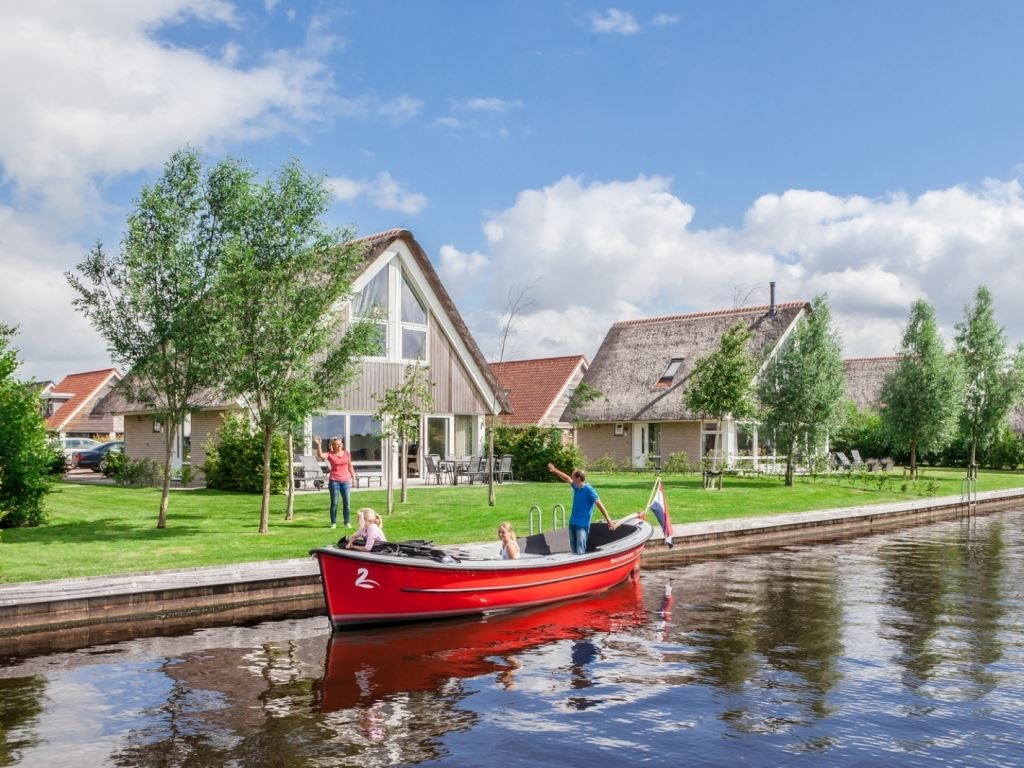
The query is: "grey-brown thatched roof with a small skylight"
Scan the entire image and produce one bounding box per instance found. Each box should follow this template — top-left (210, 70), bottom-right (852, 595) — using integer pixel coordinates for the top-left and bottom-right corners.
top-left (563, 301), bottom-right (810, 422)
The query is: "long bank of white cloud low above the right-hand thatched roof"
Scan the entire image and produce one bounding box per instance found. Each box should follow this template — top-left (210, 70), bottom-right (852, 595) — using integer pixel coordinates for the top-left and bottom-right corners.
top-left (456, 176), bottom-right (1024, 357)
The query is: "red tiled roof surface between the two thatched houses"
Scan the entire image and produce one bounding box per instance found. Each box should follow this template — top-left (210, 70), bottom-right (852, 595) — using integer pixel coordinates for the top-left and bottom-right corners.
top-left (490, 354), bottom-right (587, 425)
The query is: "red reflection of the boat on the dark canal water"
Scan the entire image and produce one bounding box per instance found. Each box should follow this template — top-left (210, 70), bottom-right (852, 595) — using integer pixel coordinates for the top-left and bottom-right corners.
top-left (314, 575), bottom-right (648, 712)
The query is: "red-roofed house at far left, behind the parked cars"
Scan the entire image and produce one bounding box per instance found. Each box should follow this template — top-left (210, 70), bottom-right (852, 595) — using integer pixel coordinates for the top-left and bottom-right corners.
top-left (39, 368), bottom-right (124, 439)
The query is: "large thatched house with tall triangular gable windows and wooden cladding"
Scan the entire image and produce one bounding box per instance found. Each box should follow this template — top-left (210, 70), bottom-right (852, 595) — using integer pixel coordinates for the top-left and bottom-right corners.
top-left (104, 229), bottom-right (507, 481)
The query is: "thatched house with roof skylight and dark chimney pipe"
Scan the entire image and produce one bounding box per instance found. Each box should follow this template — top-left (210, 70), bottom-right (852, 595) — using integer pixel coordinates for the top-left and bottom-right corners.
top-left (563, 294), bottom-right (810, 467)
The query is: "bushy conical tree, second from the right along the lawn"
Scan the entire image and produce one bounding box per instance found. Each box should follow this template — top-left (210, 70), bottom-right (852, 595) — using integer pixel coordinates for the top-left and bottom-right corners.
top-left (882, 299), bottom-right (964, 477)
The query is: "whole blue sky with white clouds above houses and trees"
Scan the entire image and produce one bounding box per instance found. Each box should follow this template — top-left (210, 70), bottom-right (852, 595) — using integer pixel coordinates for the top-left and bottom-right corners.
top-left (0, 0), bottom-right (1024, 378)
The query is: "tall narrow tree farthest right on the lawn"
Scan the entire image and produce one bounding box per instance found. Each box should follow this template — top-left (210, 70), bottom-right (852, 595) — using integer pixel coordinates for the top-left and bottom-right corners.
top-left (956, 286), bottom-right (1024, 477)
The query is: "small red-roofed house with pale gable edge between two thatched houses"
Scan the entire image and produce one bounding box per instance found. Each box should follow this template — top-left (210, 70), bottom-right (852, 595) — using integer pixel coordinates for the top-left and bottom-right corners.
top-left (490, 354), bottom-right (589, 431)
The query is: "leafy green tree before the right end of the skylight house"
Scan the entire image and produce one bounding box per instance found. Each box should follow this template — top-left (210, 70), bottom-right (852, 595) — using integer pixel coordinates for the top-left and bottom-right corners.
top-left (758, 296), bottom-right (845, 485)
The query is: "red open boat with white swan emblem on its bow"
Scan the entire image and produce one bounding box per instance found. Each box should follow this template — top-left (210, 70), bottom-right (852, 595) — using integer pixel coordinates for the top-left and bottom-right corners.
top-left (309, 516), bottom-right (652, 629)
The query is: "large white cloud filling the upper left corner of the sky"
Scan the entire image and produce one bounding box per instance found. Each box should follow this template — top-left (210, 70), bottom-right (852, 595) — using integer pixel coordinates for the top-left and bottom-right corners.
top-left (0, 0), bottom-right (331, 213)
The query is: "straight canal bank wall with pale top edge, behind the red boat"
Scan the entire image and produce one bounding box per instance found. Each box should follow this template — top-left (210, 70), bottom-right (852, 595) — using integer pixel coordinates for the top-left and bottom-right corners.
top-left (0, 488), bottom-right (1024, 652)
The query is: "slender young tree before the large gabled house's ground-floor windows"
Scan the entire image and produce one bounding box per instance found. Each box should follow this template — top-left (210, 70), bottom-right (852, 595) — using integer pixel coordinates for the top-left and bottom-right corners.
top-left (374, 362), bottom-right (434, 514)
